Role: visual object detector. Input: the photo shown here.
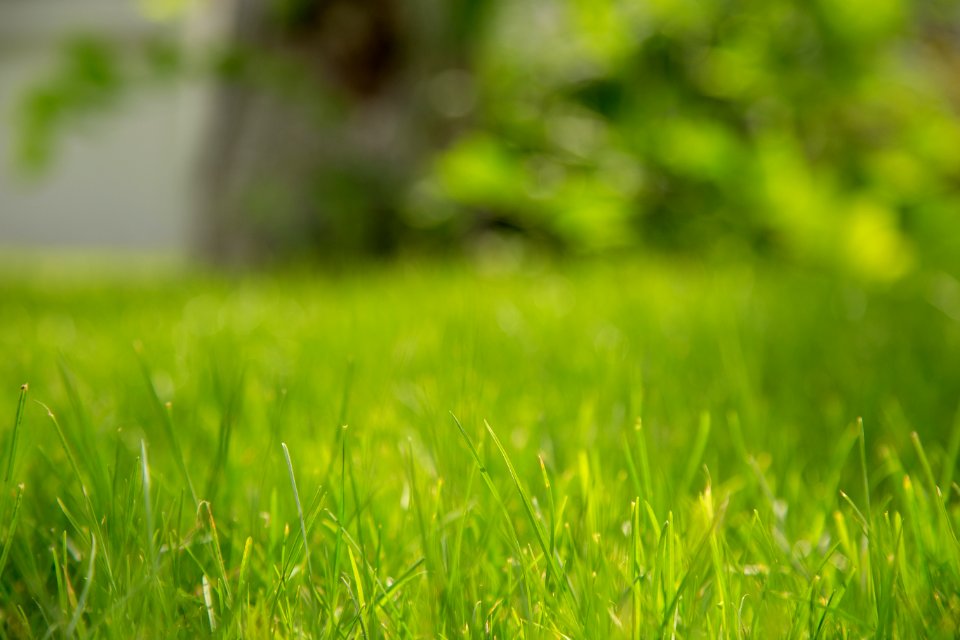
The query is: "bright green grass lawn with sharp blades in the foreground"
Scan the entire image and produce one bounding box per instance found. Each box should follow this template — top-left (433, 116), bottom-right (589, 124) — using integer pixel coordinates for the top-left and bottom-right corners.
top-left (0, 263), bottom-right (960, 639)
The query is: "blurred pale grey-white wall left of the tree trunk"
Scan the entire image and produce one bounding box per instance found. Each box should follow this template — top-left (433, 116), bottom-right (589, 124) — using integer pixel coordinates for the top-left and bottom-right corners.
top-left (0, 0), bottom-right (205, 253)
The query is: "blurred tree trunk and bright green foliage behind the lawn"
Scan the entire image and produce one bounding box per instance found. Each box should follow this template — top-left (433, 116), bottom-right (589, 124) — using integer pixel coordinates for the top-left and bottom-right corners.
top-left (11, 0), bottom-right (960, 281)
